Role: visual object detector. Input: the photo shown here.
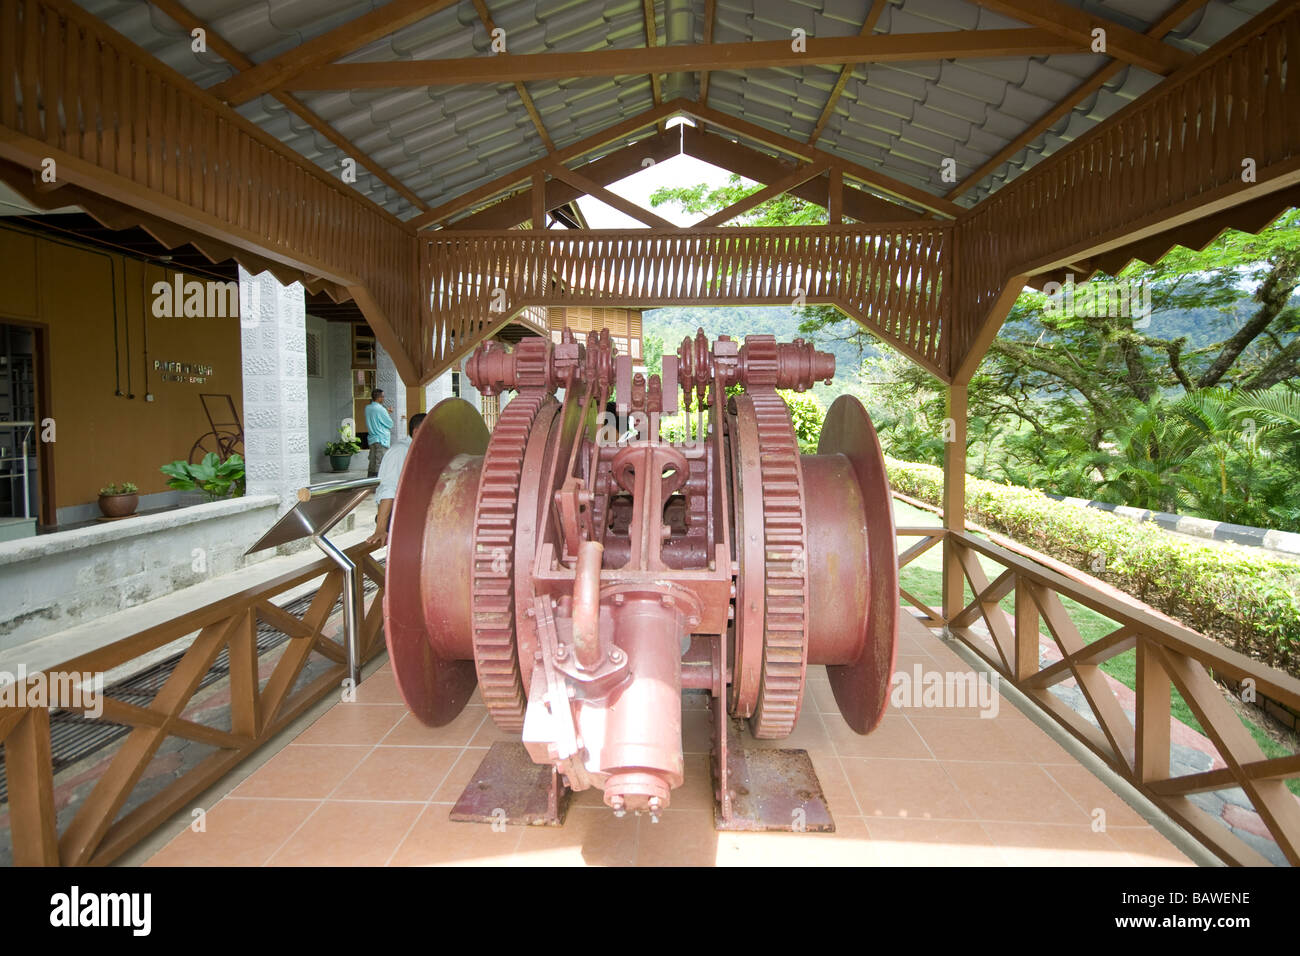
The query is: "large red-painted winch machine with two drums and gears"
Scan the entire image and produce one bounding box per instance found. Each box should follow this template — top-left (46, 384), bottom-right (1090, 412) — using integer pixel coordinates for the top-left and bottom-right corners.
top-left (384, 332), bottom-right (898, 830)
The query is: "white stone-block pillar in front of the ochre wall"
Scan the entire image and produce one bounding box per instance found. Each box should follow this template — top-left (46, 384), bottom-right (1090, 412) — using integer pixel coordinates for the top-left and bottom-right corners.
top-left (239, 267), bottom-right (311, 514)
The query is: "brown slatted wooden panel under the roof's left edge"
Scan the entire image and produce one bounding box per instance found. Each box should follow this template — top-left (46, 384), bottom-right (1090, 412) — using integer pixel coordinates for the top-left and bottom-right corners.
top-left (0, 0), bottom-right (420, 374)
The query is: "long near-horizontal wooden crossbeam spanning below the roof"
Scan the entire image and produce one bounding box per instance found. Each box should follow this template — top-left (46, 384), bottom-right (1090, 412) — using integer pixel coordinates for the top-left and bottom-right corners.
top-left (287, 29), bottom-right (1088, 90)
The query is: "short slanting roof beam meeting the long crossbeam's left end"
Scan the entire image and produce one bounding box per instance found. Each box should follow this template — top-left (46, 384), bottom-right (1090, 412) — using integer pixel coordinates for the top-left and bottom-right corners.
top-left (208, 0), bottom-right (458, 105)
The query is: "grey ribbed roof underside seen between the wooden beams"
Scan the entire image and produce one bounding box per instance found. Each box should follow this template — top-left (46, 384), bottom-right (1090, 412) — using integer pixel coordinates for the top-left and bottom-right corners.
top-left (68, 0), bottom-right (1271, 217)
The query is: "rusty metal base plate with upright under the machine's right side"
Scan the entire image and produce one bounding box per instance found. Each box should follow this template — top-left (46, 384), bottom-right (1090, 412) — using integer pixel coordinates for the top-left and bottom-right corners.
top-left (711, 701), bottom-right (835, 834)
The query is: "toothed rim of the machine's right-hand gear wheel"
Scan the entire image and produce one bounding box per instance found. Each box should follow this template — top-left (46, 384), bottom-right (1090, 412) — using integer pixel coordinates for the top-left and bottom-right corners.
top-left (746, 390), bottom-right (809, 739)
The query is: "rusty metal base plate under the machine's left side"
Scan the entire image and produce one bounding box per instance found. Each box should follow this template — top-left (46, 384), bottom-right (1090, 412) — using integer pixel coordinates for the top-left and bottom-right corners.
top-left (451, 740), bottom-right (569, 826)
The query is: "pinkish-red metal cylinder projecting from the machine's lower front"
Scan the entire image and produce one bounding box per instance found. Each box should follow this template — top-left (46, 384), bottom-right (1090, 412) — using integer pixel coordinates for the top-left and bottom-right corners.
top-left (601, 594), bottom-right (684, 810)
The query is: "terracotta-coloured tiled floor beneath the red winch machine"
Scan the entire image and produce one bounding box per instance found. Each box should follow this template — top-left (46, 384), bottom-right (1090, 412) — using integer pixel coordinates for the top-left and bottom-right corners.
top-left (142, 618), bottom-right (1190, 866)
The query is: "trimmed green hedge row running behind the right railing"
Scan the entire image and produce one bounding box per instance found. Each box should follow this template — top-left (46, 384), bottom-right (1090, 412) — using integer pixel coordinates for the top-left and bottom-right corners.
top-left (885, 457), bottom-right (1300, 676)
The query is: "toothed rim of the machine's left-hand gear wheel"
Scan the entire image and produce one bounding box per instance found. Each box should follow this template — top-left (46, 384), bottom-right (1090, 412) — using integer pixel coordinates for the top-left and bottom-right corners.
top-left (471, 389), bottom-right (550, 732)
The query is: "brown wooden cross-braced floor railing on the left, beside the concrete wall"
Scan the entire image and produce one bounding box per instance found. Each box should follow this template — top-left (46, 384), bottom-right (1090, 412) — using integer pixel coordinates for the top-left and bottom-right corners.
top-left (0, 544), bottom-right (384, 866)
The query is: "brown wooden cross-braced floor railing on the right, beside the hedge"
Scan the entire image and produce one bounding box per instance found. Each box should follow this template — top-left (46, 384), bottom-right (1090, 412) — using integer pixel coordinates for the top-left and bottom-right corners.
top-left (897, 527), bottom-right (1300, 865)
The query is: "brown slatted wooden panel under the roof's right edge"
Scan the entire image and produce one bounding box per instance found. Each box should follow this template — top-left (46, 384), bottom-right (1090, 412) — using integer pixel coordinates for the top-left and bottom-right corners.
top-left (953, 3), bottom-right (1300, 366)
